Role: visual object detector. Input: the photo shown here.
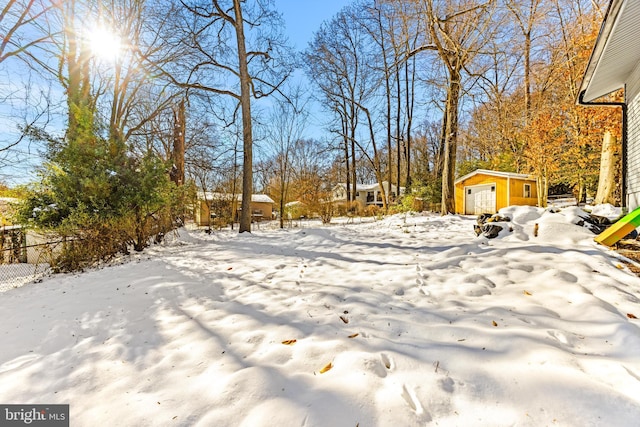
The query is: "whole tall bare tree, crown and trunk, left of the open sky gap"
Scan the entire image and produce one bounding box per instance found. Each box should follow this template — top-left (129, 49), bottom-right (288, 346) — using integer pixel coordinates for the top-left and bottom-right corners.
top-left (150, 0), bottom-right (292, 233)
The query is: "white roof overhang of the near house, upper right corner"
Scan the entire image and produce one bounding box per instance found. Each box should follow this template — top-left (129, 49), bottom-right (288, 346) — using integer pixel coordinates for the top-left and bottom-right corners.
top-left (579, 0), bottom-right (640, 102)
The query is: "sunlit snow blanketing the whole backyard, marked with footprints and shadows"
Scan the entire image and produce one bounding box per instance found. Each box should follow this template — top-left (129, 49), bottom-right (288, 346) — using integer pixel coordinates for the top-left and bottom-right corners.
top-left (0, 207), bottom-right (640, 427)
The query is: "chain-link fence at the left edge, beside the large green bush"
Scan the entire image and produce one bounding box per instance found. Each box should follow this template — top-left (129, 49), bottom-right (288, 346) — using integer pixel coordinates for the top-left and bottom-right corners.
top-left (0, 225), bottom-right (55, 292)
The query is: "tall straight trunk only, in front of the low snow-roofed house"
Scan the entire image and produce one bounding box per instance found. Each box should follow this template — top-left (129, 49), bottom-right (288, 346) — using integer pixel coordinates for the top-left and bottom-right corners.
top-left (233, 0), bottom-right (253, 233)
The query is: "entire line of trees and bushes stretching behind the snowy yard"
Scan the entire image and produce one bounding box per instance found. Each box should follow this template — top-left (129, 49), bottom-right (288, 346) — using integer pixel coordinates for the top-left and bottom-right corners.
top-left (0, 0), bottom-right (620, 268)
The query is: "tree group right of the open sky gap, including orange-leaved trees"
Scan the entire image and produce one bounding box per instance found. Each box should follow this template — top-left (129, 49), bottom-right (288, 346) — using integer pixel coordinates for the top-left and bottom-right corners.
top-left (304, 0), bottom-right (621, 213)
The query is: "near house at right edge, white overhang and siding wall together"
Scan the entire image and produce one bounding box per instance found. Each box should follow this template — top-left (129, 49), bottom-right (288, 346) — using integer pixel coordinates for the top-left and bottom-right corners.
top-left (578, 0), bottom-right (640, 210)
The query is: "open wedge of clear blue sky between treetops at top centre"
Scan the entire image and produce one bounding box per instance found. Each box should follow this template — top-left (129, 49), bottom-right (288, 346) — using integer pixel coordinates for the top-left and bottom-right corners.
top-left (274, 0), bottom-right (352, 50)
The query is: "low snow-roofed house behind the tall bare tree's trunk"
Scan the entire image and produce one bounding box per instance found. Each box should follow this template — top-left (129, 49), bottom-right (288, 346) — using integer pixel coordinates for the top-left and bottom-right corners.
top-left (194, 191), bottom-right (275, 226)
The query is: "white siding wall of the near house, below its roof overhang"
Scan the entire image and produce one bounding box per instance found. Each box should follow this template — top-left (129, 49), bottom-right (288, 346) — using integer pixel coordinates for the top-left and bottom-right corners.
top-left (626, 64), bottom-right (640, 210)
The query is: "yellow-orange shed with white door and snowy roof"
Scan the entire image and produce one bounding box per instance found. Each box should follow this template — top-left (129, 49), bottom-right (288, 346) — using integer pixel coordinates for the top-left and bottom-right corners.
top-left (455, 169), bottom-right (538, 215)
